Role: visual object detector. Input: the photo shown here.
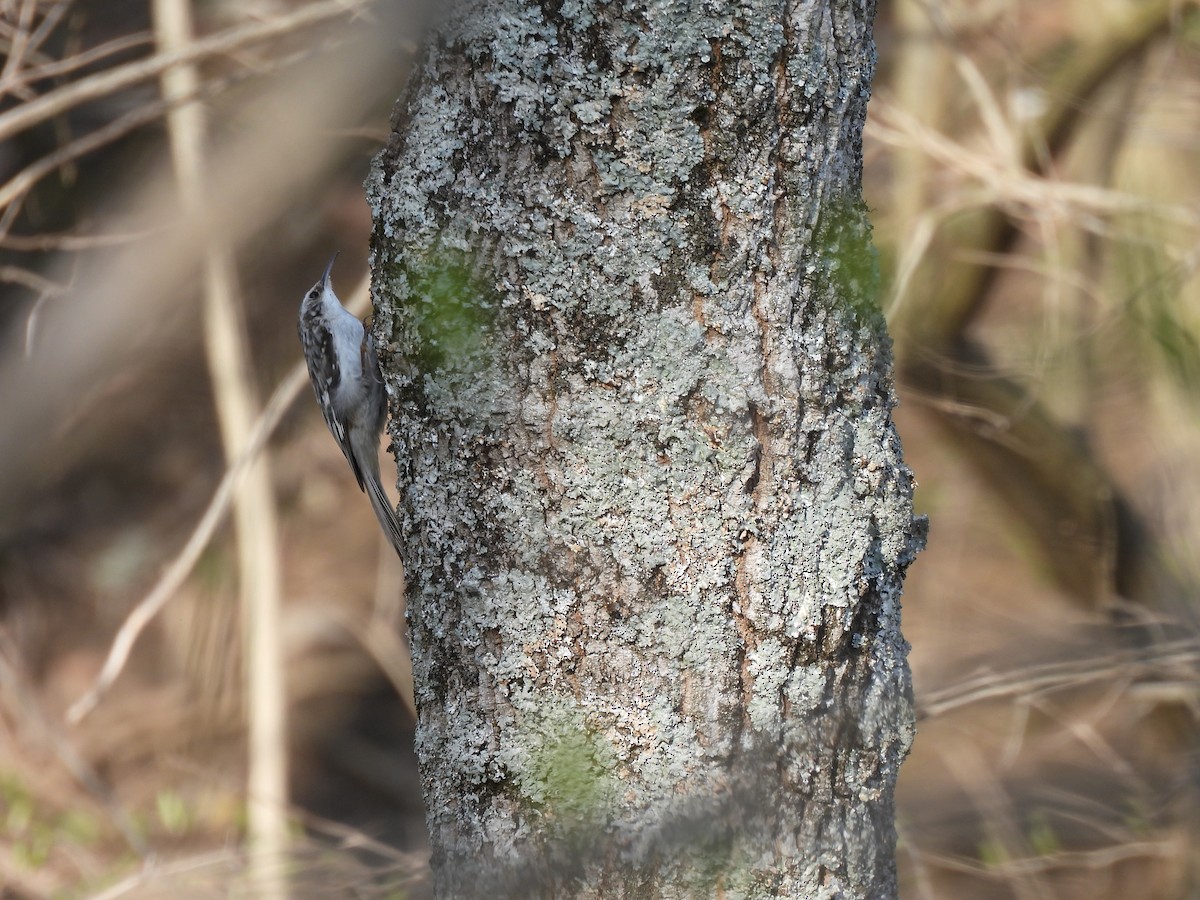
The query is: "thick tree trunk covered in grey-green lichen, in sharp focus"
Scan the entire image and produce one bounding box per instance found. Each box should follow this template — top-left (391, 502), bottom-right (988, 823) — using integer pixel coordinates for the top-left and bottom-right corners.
top-left (368, 0), bottom-right (924, 898)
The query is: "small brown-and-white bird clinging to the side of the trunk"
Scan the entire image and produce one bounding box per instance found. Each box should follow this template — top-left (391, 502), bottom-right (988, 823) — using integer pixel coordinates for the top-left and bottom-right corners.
top-left (300, 253), bottom-right (400, 553)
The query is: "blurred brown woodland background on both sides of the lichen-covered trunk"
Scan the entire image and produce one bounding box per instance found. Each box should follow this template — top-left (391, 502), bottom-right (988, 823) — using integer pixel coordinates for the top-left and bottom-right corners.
top-left (0, 0), bottom-right (1200, 899)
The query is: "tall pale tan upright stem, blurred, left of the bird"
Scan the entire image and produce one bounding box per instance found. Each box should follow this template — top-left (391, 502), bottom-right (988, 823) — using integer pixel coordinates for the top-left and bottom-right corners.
top-left (152, 0), bottom-right (288, 900)
